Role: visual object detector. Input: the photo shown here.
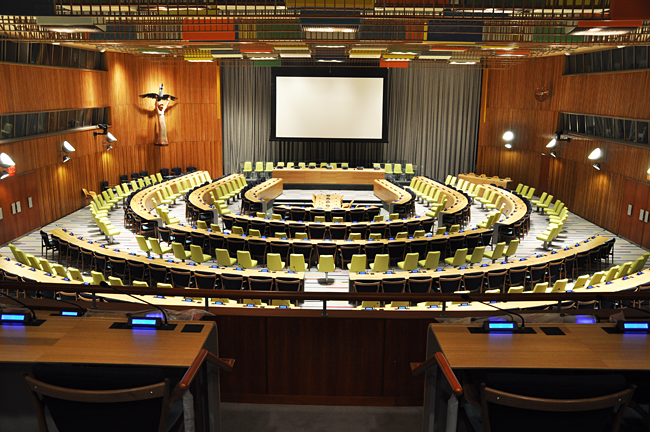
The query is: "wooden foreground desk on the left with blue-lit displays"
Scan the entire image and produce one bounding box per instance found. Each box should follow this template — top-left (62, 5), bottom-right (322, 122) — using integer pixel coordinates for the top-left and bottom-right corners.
top-left (0, 312), bottom-right (220, 432)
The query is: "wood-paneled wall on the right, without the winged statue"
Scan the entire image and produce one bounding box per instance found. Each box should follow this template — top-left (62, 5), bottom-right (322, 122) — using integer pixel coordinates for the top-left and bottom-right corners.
top-left (477, 56), bottom-right (650, 233)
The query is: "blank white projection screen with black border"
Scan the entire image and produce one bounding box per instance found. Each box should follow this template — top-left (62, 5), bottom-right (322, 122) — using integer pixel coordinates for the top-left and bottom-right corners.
top-left (271, 68), bottom-right (387, 142)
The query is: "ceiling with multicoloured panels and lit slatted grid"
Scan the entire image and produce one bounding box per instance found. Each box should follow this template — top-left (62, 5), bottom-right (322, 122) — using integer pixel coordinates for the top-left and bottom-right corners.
top-left (0, 0), bottom-right (650, 69)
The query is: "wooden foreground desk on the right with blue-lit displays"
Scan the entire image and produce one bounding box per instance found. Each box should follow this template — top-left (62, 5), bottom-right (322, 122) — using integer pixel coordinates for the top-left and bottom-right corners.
top-left (422, 323), bottom-right (650, 432)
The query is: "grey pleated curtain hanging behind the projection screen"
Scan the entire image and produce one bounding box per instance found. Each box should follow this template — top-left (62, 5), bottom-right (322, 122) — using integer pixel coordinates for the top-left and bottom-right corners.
top-left (221, 67), bottom-right (481, 178)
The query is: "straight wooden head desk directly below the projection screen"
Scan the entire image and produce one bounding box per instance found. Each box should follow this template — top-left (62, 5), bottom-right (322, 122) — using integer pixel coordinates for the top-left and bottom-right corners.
top-left (273, 168), bottom-right (384, 185)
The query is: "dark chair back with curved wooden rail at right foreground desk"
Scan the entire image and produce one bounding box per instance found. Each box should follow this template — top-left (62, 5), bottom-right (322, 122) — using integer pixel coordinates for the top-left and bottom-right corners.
top-left (480, 374), bottom-right (635, 432)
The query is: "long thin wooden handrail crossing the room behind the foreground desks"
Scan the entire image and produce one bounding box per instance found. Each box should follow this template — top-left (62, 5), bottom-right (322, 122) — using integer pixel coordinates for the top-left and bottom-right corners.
top-left (0, 281), bottom-right (650, 309)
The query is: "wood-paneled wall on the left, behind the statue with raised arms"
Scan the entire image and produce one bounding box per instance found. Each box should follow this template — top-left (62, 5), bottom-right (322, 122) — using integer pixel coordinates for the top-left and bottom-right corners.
top-left (0, 53), bottom-right (223, 240)
